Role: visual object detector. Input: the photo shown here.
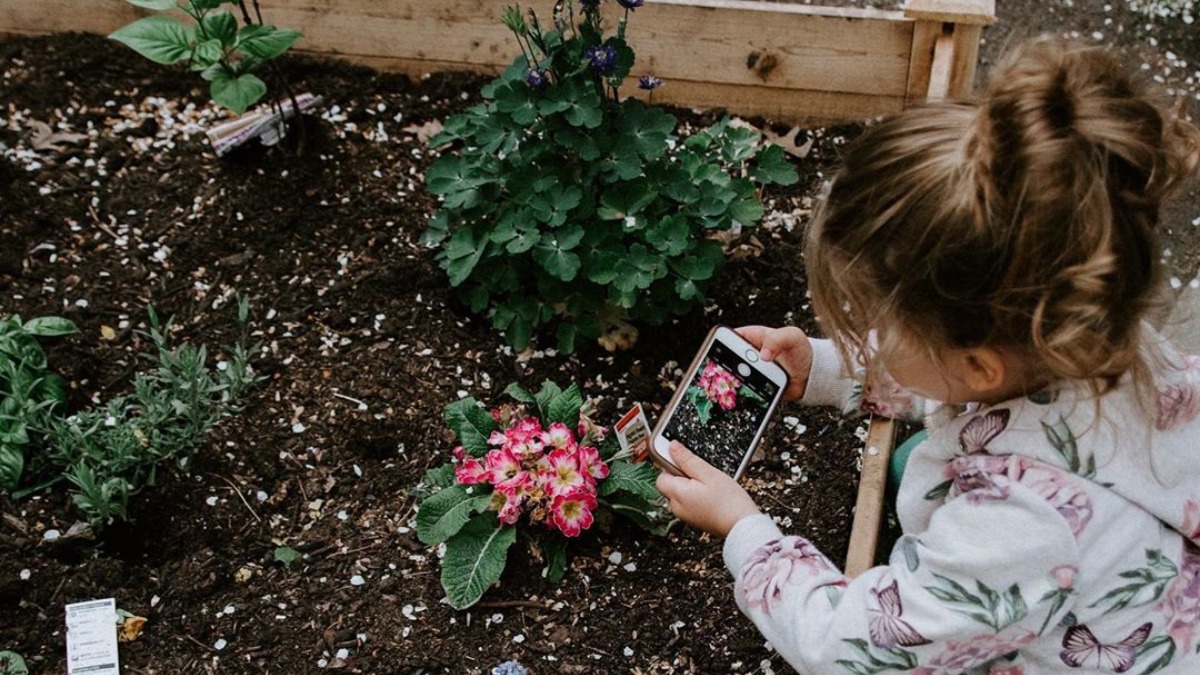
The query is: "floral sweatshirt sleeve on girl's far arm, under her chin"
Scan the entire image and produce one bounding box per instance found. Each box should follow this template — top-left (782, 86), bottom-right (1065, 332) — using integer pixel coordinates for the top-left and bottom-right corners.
top-left (800, 339), bottom-right (932, 420)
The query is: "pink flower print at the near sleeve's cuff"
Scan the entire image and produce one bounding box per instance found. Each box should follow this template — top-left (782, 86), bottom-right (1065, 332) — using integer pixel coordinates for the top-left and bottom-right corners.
top-left (740, 537), bottom-right (845, 616)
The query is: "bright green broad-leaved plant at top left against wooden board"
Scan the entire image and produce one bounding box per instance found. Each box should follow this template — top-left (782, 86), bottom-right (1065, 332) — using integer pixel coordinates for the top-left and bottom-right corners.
top-left (109, 0), bottom-right (301, 114)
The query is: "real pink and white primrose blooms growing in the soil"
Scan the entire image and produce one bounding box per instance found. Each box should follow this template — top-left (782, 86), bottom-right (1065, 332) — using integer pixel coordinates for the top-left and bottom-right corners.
top-left (454, 408), bottom-right (608, 537)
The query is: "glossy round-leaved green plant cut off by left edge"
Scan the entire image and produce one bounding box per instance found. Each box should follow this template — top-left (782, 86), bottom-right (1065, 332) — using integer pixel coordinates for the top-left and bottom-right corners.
top-left (0, 315), bottom-right (79, 491)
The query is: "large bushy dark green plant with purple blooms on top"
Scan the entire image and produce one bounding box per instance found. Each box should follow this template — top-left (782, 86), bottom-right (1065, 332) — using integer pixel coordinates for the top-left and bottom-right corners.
top-left (422, 0), bottom-right (797, 352)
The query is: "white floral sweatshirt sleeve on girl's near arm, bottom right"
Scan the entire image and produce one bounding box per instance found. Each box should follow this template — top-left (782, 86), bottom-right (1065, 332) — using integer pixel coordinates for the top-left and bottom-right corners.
top-left (724, 478), bottom-right (1079, 673)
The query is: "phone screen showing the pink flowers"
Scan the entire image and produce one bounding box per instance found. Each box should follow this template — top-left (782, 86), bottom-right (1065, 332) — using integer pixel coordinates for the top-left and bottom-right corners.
top-left (662, 341), bottom-right (781, 476)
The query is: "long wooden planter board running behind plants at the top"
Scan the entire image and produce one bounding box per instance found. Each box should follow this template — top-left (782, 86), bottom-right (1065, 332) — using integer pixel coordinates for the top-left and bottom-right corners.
top-left (0, 0), bottom-right (995, 125)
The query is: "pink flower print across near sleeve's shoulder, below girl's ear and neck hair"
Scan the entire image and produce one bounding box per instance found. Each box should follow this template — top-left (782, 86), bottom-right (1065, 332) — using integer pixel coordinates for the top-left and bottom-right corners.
top-left (943, 455), bottom-right (1093, 536)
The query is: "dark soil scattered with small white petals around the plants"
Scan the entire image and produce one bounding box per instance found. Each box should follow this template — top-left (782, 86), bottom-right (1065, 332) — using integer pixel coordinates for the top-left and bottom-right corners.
top-left (0, 0), bottom-right (1200, 674)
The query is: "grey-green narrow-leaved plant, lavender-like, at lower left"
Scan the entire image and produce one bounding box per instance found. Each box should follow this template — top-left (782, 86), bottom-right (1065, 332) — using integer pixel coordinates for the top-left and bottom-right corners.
top-left (10, 298), bottom-right (260, 528)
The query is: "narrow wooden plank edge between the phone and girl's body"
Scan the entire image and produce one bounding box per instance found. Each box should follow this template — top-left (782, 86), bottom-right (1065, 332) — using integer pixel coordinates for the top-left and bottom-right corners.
top-left (846, 417), bottom-right (896, 577)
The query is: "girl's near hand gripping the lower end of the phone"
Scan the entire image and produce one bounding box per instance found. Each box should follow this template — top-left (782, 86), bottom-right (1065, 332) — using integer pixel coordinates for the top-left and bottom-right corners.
top-left (658, 441), bottom-right (758, 537)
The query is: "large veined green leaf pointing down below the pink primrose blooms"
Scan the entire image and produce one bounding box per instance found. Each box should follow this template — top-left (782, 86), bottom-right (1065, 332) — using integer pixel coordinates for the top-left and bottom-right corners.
top-left (442, 512), bottom-right (517, 609)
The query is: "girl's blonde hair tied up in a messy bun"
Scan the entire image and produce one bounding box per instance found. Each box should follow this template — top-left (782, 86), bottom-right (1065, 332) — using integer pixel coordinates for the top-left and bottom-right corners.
top-left (806, 38), bottom-right (1200, 393)
